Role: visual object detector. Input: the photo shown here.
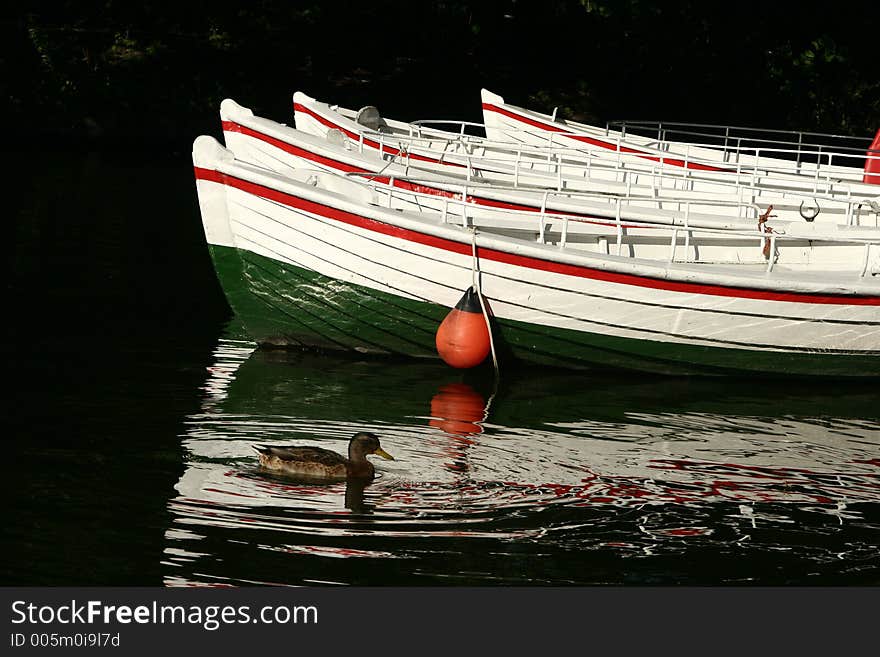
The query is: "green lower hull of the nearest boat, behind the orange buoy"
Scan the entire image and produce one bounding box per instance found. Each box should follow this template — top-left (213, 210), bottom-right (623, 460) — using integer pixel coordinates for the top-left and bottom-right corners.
top-left (210, 245), bottom-right (880, 376)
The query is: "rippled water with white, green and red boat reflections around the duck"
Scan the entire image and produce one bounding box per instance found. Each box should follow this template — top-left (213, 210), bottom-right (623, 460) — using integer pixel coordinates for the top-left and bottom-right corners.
top-left (164, 343), bottom-right (880, 585)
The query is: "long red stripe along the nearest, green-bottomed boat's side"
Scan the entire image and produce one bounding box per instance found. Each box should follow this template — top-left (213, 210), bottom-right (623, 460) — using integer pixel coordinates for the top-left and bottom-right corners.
top-left (195, 167), bottom-right (880, 306)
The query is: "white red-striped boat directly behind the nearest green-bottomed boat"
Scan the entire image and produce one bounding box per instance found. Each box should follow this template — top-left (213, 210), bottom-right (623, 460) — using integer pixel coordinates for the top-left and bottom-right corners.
top-left (220, 99), bottom-right (880, 268)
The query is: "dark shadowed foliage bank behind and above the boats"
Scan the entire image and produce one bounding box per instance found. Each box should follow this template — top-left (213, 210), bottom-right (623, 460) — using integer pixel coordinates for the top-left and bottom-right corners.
top-left (0, 0), bottom-right (880, 150)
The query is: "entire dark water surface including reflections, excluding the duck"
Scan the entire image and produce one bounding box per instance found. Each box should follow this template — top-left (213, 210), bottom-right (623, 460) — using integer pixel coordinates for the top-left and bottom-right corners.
top-left (2, 150), bottom-right (880, 586)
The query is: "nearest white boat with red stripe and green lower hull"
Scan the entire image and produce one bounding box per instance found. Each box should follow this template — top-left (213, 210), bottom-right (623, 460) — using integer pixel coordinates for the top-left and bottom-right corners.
top-left (193, 137), bottom-right (880, 376)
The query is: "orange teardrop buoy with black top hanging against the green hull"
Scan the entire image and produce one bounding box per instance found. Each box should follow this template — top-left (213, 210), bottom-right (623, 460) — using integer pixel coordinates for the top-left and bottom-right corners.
top-left (437, 287), bottom-right (490, 369)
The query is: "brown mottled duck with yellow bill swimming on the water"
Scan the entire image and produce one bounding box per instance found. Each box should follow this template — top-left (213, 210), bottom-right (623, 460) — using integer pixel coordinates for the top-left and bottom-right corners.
top-left (254, 431), bottom-right (394, 480)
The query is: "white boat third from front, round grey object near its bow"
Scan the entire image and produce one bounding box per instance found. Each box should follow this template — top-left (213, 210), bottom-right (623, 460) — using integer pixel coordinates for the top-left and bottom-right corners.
top-left (294, 92), bottom-right (880, 226)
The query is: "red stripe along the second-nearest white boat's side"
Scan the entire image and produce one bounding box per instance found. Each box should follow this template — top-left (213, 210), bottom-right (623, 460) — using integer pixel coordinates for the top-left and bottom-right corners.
top-left (223, 121), bottom-right (634, 228)
